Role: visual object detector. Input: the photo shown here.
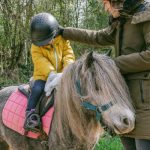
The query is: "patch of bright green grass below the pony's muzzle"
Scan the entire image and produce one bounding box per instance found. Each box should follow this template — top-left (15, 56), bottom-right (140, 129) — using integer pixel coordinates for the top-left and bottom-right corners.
top-left (94, 135), bottom-right (124, 150)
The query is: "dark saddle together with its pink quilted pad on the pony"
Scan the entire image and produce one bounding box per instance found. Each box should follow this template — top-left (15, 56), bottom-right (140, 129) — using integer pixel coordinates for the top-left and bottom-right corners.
top-left (2, 85), bottom-right (55, 140)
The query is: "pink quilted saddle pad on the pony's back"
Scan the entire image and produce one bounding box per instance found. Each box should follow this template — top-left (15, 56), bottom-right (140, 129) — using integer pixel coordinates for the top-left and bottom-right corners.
top-left (2, 90), bottom-right (54, 139)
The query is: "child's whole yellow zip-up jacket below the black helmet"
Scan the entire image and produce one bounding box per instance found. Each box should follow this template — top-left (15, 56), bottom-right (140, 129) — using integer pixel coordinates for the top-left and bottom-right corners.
top-left (31, 36), bottom-right (75, 81)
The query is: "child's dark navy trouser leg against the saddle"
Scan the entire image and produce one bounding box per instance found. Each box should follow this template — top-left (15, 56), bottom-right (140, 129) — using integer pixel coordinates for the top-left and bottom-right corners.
top-left (26, 80), bottom-right (45, 111)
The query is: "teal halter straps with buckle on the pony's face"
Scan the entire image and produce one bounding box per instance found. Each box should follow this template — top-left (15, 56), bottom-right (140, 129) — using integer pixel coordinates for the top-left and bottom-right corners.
top-left (75, 80), bottom-right (113, 123)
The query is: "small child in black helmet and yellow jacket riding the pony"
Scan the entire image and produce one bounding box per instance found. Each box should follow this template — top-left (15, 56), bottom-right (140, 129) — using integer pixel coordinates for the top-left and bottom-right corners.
top-left (24, 13), bottom-right (75, 131)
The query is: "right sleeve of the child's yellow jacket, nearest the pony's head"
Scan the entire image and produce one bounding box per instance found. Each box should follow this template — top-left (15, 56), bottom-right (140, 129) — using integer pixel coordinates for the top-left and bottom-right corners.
top-left (63, 40), bottom-right (75, 68)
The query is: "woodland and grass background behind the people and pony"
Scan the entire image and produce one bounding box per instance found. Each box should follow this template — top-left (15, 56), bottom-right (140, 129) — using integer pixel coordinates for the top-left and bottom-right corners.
top-left (0, 0), bottom-right (123, 150)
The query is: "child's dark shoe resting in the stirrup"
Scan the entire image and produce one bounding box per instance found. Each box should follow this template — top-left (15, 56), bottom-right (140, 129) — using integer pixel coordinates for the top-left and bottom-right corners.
top-left (24, 113), bottom-right (42, 133)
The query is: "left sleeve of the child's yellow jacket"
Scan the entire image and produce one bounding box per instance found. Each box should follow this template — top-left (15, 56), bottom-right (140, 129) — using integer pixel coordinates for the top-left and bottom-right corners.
top-left (31, 45), bottom-right (55, 77)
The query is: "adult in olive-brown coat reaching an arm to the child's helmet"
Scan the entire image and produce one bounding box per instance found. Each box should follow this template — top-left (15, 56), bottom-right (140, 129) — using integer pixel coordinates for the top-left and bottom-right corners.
top-left (56, 0), bottom-right (150, 150)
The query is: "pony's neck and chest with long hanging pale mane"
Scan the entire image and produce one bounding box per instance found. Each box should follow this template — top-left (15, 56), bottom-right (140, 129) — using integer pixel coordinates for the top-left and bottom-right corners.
top-left (50, 68), bottom-right (102, 150)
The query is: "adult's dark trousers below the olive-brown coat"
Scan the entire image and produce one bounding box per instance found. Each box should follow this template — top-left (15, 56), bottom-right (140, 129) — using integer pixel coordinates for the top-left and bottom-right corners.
top-left (121, 137), bottom-right (150, 150)
